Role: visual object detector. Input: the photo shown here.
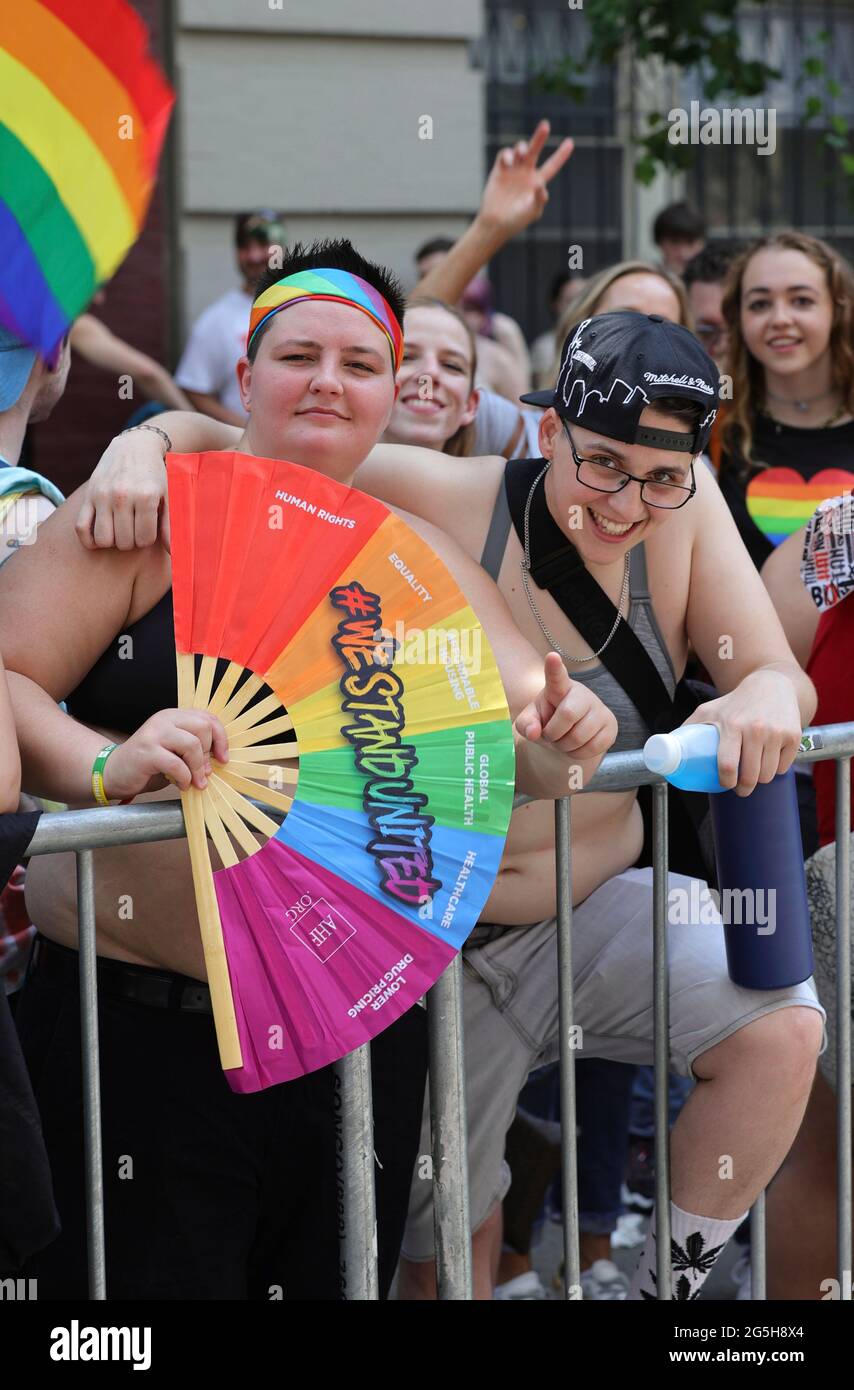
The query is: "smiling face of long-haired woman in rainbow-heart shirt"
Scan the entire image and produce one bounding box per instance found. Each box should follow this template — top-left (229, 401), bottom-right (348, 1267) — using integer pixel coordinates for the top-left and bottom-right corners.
top-left (740, 247), bottom-right (833, 375)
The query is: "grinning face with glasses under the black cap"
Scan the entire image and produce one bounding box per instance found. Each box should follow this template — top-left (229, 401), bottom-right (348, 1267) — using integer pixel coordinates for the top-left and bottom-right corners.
top-left (540, 406), bottom-right (691, 564)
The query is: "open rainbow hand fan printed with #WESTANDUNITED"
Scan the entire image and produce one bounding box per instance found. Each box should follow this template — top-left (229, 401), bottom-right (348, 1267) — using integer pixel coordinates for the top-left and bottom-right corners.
top-left (167, 453), bottom-right (515, 1091)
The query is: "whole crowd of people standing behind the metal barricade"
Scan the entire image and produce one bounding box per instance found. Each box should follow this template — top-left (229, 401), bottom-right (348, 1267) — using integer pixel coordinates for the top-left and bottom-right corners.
top-left (0, 122), bottom-right (854, 1301)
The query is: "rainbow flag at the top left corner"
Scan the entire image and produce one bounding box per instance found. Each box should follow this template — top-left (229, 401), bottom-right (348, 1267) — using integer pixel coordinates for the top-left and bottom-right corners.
top-left (0, 0), bottom-right (174, 357)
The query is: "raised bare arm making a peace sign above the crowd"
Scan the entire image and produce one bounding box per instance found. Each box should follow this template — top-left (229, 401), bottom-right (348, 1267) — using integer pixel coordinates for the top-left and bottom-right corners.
top-left (419, 121), bottom-right (573, 304)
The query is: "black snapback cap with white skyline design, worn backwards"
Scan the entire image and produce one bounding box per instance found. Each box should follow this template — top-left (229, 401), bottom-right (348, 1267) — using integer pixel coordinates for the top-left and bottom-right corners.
top-left (520, 310), bottom-right (719, 455)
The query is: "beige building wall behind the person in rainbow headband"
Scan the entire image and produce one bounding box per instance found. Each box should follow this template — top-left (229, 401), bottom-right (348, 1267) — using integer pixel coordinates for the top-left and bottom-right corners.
top-left (175, 0), bottom-right (484, 338)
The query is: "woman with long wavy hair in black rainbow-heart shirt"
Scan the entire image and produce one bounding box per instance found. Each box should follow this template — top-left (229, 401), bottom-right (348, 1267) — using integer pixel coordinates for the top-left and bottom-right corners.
top-left (719, 231), bottom-right (854, 566)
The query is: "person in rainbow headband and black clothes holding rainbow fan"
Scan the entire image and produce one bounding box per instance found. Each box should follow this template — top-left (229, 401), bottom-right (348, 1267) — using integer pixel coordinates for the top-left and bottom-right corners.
top-left (0, 243), bottom-right (616, 1300)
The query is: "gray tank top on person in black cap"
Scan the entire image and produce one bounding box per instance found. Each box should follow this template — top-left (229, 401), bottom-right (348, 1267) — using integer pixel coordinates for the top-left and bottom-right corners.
top-left (480, 478), bottom-right (676, 752)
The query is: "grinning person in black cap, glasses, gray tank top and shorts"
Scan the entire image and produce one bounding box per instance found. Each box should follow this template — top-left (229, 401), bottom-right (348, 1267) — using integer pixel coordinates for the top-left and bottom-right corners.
top-left (78, 311), bottom-right (823, 1298)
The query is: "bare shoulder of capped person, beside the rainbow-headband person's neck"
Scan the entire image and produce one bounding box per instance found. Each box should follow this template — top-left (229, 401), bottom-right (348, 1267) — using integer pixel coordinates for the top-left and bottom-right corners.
top-left (355, 443), bottom-right (505, 556)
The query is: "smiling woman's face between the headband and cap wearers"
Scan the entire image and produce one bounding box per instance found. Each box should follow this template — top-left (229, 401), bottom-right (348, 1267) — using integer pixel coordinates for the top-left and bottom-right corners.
top-left (382, 306), bottom-right (477, 449)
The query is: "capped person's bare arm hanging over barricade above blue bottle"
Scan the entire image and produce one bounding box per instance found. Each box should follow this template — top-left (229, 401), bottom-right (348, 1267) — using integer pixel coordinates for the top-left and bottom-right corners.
top-left (686, 458), bottom-right (816, 795)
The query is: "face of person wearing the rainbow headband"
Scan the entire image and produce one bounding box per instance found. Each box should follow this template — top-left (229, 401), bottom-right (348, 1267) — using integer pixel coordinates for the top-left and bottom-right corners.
top-left (238, 300), bottom-right (395, 482)
